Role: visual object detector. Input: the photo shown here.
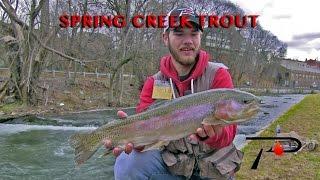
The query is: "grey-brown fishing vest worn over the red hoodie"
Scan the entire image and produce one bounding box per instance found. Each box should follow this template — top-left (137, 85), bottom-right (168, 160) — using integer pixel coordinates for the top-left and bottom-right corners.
top-left (153, 62), bottom-right (243, 179)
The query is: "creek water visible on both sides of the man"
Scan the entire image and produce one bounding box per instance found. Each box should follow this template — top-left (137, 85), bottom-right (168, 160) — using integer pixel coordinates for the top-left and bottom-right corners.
top-left (0, 95), bottom-right (303, 179)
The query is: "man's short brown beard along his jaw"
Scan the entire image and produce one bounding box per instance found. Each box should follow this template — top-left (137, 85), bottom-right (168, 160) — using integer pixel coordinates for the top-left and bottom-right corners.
top-left (168, 40), bottom-right (200, 66)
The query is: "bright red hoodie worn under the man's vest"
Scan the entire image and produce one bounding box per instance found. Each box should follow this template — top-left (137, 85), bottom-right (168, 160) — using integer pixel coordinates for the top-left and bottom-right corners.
top-left (136, 50), bottom-right (237, 148)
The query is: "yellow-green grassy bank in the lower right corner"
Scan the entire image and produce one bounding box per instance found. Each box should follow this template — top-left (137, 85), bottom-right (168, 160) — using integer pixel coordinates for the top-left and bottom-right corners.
top-left (237, 94), bottom-right (320, 180)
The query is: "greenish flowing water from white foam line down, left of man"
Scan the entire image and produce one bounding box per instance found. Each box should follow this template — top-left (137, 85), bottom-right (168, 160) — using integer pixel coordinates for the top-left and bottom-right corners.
top-left (0, 124), bottom-right (114, 179)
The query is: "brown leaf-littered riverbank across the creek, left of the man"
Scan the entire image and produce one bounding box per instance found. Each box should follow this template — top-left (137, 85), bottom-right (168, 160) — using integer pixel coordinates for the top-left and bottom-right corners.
top-left (0, 76), bottom-right (139, 123)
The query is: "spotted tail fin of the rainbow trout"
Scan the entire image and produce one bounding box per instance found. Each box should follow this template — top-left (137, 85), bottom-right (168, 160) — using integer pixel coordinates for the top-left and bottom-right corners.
top-left (69, 133), bottom-right (102, 166)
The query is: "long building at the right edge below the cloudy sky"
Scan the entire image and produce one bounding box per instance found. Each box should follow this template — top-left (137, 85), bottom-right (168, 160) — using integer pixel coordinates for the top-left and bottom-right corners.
top-left (277, 59), bottom-right (320, 88)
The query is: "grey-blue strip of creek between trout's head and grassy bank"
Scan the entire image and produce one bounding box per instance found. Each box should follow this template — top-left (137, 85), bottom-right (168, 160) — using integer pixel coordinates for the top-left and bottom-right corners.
top-left (233, 94), bottom-right (305, 149)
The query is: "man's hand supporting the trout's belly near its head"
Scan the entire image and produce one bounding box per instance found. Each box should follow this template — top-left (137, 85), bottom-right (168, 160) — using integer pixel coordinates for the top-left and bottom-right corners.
top-left (189, 125), bottom-right (223, 142)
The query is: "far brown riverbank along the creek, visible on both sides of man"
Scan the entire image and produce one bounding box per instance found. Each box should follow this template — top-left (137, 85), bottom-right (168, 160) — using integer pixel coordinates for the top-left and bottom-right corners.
top-left (0, 84), bottom-right (318, 123)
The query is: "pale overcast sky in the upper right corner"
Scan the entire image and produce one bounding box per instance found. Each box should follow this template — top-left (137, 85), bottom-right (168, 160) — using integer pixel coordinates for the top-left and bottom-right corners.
top-left (231, 0), bottom-right (320, 60)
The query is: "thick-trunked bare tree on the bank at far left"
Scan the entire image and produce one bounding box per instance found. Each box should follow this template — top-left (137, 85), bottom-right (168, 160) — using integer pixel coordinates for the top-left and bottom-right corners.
top-left (0, 0), bottom-right (86, 105)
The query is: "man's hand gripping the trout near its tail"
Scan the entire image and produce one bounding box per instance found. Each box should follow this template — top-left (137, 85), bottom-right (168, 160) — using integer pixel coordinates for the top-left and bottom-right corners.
top-left (103, 111), bottom-right (144, 157)
